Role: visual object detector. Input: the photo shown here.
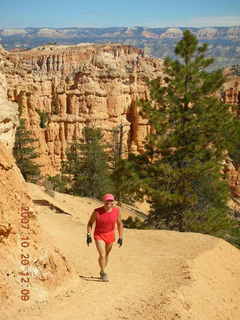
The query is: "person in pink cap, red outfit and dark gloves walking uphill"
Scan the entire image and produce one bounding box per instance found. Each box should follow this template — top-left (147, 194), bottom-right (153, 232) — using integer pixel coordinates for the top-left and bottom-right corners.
top-left (87, 193), bottom-right (123, 281)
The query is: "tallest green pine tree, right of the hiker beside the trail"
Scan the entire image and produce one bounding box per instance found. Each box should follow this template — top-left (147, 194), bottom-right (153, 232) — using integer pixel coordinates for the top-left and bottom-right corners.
top-left (129, 30), bottom-right (240, 237)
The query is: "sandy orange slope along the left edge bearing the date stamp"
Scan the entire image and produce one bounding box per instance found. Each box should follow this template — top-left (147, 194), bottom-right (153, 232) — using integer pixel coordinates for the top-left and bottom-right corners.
top-left (0, 47), bottom-right (74, 318)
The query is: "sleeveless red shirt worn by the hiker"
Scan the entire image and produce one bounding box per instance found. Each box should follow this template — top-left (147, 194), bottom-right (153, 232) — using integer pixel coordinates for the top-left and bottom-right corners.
top-left (94, 206), bottom-right (119, 233)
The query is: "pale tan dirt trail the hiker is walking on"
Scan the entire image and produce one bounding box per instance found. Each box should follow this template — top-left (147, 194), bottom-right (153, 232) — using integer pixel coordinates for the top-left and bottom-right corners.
top-left (12, 184), bottom-right (240, 320)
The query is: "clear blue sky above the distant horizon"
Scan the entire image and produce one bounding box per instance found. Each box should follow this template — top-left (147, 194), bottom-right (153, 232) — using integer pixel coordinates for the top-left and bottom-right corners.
top-left (0, 0), bottom-right (240, 28)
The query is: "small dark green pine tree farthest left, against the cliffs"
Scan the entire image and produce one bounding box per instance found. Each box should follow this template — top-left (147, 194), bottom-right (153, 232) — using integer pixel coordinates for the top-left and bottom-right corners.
top-left (13, 118), bottom-right (40, 182)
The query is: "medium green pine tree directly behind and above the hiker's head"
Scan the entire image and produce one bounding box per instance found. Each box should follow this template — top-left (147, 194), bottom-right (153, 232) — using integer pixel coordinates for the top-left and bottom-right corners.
top-left (62, 127), bottom-right (113, 199)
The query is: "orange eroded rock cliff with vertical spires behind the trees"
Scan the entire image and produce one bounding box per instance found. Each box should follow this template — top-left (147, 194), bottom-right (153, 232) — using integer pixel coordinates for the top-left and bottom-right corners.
top-left (5, 44), bottom-right (162, 175)
